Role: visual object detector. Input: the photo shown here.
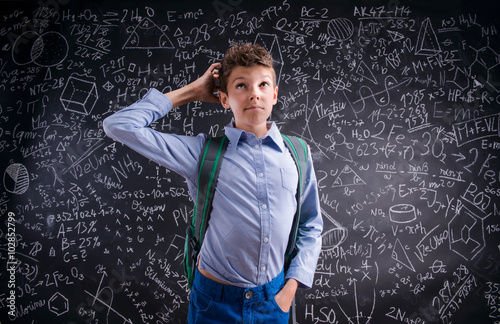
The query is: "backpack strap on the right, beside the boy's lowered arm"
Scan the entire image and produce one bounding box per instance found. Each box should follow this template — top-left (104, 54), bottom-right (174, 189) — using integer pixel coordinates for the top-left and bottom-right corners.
top-left (281, 134), bottom-right (307, 259)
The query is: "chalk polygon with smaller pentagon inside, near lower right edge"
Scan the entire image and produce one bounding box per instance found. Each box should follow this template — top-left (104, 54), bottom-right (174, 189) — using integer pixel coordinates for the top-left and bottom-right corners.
top-left (448, 201), bottom-right (489, 261)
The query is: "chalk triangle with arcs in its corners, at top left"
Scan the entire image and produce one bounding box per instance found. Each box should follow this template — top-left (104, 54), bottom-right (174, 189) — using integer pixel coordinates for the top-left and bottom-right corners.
top-left (123, 18), bottom-right (174, 49)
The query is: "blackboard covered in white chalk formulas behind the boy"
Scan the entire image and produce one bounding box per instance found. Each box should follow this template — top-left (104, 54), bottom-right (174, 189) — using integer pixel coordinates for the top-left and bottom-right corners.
top-left (0, 0), bottom-right (500, 324)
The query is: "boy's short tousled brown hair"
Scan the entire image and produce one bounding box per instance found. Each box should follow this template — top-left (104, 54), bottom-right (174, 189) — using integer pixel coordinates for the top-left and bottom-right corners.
top-left (219, 43), bottom-right (276, 93)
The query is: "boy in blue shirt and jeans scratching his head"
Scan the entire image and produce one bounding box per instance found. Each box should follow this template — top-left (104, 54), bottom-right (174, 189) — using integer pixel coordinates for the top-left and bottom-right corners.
top-left (104, 44), bottom-right (323, 324)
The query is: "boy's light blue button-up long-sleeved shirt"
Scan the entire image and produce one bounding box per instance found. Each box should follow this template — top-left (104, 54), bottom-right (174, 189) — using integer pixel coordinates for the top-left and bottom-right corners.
top-left (103, 89), bottom-right (323, 288)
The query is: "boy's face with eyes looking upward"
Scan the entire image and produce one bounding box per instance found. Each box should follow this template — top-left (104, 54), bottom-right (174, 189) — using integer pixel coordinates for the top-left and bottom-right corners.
top-left (219, 65), bottom-right (278, 138)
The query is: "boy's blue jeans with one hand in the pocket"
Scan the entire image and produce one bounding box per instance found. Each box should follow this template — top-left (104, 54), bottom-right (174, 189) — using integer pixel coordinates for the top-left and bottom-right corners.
top-left (188, 269), bottom-right (289, 324)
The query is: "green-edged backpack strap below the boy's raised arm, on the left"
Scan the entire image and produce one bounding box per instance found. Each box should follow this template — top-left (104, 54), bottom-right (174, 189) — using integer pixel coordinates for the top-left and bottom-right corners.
top-left (184, 136), bottom-right (228, 288)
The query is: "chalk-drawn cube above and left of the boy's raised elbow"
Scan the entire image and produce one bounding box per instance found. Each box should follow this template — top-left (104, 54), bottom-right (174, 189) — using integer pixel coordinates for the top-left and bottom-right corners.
top-left (60, 76), bottom-right (99, 115)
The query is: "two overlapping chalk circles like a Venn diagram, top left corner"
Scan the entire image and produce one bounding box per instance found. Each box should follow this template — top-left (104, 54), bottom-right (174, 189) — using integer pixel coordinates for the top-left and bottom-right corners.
top-left (12, 31), bottom-right (69, 67)
